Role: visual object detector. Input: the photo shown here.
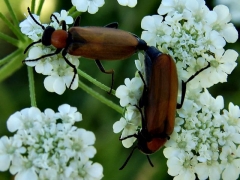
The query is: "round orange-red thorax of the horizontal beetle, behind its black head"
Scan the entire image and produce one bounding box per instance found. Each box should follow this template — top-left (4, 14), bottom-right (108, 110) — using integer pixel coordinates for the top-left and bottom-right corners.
top-left (51, 29), bottom-right (68, 49)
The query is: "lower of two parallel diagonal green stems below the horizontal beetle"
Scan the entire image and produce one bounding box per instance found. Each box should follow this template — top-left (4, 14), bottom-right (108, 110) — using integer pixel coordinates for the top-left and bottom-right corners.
top-left (78, 81), bottom-right (123, 114)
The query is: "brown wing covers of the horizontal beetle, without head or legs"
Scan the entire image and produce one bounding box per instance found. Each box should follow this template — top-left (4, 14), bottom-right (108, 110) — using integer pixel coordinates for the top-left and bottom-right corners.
top-left (67, 27), bottom-right (138, 60)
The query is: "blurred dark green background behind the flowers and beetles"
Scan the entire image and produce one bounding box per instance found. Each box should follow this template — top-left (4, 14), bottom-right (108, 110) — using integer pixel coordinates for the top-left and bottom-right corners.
top-left (0, 0), bottom-right (240, 180)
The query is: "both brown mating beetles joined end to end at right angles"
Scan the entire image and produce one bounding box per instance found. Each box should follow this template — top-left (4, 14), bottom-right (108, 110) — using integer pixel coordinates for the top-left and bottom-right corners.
top-left (24, 8), bottom-right (210, 169)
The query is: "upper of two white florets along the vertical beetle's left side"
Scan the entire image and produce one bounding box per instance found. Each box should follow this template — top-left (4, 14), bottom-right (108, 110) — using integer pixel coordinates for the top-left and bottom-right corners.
top-left (116, 77), bottom-right (143, 107)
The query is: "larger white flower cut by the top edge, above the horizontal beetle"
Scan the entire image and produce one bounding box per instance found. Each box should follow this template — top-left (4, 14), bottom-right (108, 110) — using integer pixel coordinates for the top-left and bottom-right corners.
top-left (72, 0), bottom-right (105, 14)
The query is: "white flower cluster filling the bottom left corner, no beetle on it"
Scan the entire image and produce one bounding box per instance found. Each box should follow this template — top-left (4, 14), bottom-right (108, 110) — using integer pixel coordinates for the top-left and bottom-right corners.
top-left (0, 104), bottom-right (103, 180)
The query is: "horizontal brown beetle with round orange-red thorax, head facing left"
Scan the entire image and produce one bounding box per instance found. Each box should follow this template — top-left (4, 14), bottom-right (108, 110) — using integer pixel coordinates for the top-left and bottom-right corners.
top-left (23, 8), bottom-right (147, 92)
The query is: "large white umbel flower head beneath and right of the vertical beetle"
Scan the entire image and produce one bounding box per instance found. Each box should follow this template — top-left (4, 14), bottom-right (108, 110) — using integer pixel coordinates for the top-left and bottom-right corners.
top-left (113, 0), bottom-right (240, 180)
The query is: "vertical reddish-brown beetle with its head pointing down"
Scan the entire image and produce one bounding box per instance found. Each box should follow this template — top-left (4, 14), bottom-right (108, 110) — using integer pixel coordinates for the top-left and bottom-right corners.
top-left (120, 47), bottom-right (210, 170)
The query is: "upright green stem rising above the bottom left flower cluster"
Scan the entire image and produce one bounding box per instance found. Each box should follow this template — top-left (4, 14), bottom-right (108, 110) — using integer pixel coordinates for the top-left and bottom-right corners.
top-left (27, 66), bottom-right (37, 107)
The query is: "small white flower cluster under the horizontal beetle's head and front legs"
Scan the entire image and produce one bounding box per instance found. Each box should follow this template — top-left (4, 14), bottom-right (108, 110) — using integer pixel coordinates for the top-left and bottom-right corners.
top-left (19, 10), bottom-right (79, 94)
